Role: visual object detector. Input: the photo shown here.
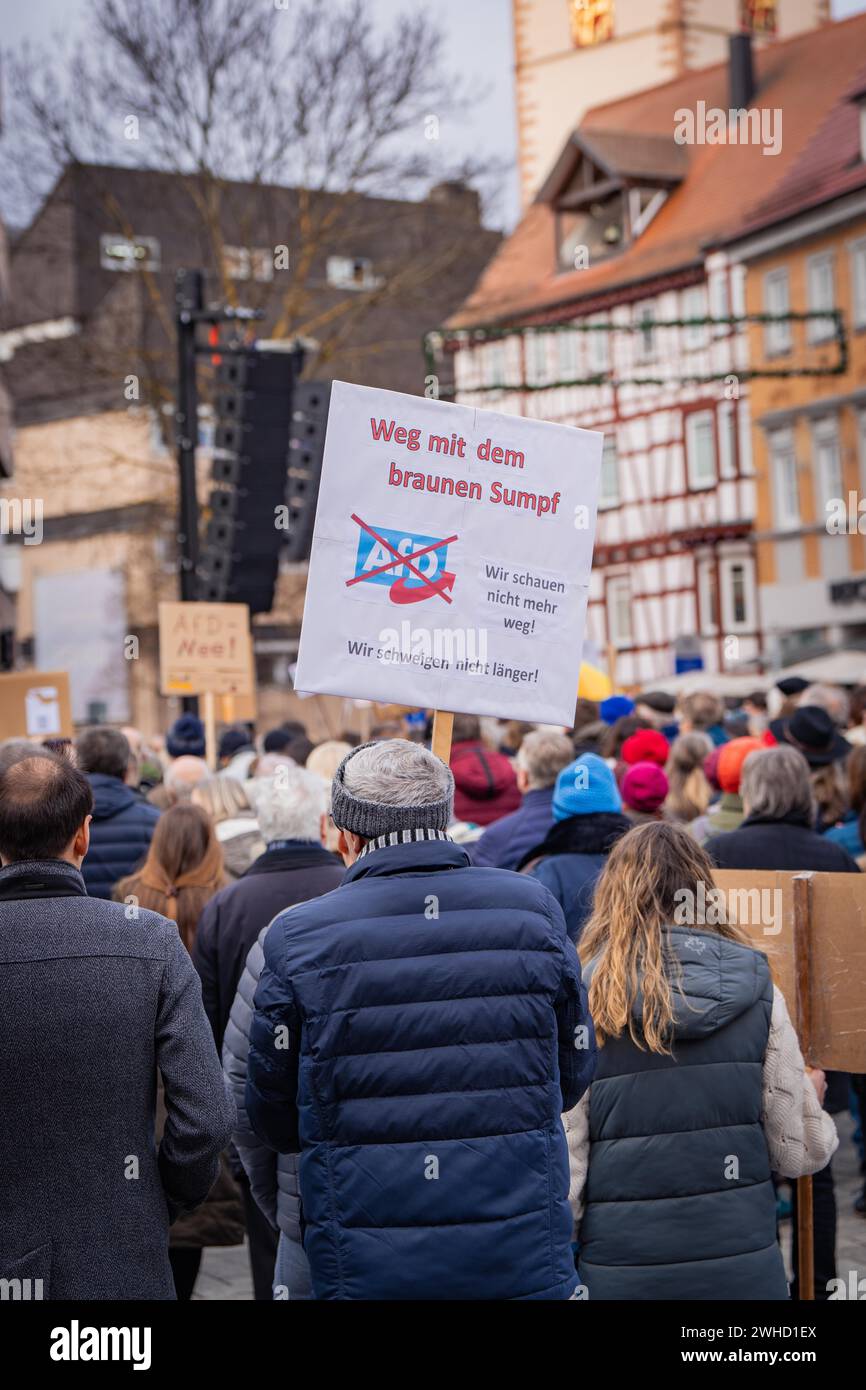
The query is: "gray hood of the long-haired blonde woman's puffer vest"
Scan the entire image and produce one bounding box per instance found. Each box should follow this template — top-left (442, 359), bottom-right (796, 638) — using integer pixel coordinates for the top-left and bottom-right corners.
top-left (632, 926), bottom-right (767, 1038)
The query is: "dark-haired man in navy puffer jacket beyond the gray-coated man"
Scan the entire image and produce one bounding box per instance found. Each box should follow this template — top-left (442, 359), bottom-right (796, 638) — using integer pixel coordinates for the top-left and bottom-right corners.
top-left (75, 726), bottom-right (160, 898)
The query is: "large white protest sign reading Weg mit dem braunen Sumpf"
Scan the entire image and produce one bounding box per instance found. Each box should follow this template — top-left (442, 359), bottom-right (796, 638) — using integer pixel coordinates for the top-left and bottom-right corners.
top-left (295, 381), bottom-right (602, 724)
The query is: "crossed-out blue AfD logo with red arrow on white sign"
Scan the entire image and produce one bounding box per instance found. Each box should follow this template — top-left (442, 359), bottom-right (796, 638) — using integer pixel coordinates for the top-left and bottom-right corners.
top-left (346, 513), bottom-right (457, 603)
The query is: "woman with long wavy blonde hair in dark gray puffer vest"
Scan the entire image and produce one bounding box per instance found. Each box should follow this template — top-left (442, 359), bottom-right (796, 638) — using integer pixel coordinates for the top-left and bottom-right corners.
top-left (564, 821), bottom-right (838, 1300)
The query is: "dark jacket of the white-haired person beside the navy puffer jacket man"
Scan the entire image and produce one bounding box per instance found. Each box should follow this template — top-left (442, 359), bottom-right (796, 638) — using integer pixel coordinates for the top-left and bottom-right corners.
top-left (192, 844), bottom-right (343, 1048)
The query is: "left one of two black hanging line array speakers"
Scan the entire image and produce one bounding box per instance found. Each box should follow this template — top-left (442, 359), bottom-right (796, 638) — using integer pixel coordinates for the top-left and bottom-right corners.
top-left (199, 349), bottom-right (302, 613)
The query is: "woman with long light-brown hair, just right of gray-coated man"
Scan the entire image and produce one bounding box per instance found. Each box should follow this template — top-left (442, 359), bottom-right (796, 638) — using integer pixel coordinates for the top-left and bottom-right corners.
top-left (114, 802), bottom-right (245, 1300)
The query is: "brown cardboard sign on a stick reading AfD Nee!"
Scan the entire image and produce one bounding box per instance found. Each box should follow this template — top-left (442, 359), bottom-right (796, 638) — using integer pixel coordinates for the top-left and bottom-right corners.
top-left (160, 603), bottom-right (254, 695)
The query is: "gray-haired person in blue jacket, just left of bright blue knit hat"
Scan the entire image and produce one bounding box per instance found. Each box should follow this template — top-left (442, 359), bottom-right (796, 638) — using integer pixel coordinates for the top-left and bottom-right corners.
top-left (468, 728), bottom-right (574, 869)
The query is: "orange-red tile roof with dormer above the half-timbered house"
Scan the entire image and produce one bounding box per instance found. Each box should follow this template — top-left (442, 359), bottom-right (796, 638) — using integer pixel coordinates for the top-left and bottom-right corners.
top-left (449, 14), bottom-right (866, 327)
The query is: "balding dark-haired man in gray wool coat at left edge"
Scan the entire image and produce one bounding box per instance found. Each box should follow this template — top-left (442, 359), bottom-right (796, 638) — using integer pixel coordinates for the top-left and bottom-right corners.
top-left (0, 749), bottom-right (235, 1300)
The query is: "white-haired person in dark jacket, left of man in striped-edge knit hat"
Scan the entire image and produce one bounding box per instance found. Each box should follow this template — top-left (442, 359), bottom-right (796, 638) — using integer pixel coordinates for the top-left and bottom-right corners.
top-left (193, 763), bottom-right (343, 1301)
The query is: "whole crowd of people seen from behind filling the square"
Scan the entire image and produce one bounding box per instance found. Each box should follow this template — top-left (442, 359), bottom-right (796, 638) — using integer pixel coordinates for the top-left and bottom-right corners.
top-left (0, 678), bottom-right (866, 1300)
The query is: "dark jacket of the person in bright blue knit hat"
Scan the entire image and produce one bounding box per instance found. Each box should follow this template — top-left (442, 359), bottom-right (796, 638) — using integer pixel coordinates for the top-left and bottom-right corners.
top-left (520, 810), bottom-right (631, 942)
